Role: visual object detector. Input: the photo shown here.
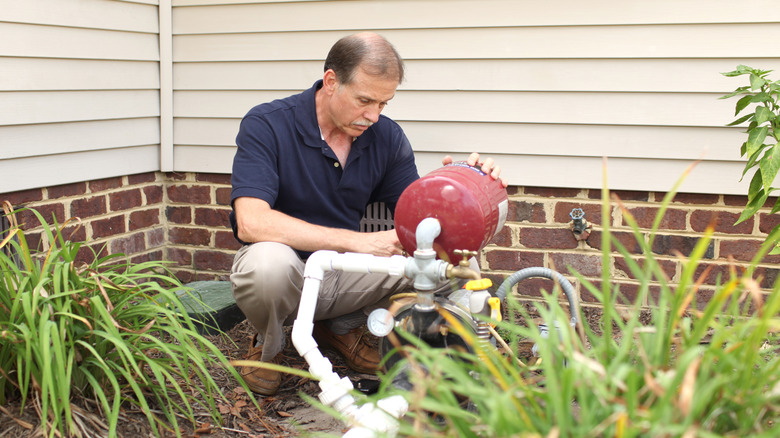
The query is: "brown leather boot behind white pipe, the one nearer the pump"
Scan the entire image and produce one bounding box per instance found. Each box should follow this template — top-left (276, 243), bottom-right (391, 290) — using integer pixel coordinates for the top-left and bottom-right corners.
top-left (313, 322), bottom-right (381, 374)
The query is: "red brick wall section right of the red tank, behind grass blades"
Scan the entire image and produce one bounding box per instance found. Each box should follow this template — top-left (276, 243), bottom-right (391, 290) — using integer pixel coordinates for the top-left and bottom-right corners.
top-left (481, 187), bottom-right (780, 306)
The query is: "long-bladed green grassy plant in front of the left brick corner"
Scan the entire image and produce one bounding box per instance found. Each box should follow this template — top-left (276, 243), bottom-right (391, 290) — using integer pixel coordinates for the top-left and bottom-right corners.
top-left (0, 205), bottom-right (250, 436)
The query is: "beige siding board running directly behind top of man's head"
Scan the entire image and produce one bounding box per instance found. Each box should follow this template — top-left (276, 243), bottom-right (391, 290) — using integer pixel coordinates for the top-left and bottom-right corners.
top-left (174, 24), bottom-right (777, 61)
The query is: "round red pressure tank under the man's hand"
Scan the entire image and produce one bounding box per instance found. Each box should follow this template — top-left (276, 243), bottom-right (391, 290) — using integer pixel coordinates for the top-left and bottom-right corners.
top-left (395, 161), bottom-right (509, 264)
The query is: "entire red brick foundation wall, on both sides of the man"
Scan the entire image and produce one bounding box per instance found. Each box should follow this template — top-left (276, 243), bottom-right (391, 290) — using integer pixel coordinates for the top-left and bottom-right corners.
top-left (0, 173), bottom-right (780, 305)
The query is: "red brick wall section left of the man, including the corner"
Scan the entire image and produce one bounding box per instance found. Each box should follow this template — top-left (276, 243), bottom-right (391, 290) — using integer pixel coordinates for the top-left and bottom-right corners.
top-left (0, 173), bottom-right (239, 282)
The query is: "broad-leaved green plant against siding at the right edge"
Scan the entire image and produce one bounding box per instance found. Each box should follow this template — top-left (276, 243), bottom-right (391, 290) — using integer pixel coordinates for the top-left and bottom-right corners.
top-left (721, 65), bottom-right (780, 250)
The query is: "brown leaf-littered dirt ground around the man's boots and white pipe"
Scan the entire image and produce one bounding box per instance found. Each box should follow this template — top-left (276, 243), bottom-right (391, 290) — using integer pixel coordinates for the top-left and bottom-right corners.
top-left (0, 321), bottom-right (378, 438)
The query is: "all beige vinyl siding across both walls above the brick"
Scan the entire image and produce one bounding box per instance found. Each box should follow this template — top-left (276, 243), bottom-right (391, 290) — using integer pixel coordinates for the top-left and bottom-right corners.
top-left (0, 0), bottom-right (780, 194)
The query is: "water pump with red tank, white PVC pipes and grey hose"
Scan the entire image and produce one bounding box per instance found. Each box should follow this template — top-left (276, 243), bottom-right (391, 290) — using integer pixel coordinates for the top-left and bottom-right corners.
top-left (292, 162), bottom-right (576, 438)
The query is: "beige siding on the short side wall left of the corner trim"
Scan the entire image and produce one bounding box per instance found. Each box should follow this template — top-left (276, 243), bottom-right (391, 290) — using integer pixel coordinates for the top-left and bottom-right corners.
top-left (0, 0), bottom-right (160, 192)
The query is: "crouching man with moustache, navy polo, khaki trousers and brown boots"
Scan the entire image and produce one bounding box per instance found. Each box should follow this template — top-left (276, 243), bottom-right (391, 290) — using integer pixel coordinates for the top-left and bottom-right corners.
top-left (230, 33), bottom-right (506, 395)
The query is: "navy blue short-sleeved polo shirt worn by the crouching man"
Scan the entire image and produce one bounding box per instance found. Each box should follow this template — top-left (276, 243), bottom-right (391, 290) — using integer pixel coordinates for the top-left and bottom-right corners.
top-left (231, 80), bottom-right (419, 257)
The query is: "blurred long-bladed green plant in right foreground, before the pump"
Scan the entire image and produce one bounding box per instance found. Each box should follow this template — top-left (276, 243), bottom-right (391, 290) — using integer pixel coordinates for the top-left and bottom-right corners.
top-left (362, 170), bottom-right (780, 437)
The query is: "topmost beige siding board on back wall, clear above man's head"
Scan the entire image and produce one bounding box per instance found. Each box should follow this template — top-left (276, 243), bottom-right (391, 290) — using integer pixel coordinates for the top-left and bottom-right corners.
top-left (173, 0), bottom-right (777, 29)
